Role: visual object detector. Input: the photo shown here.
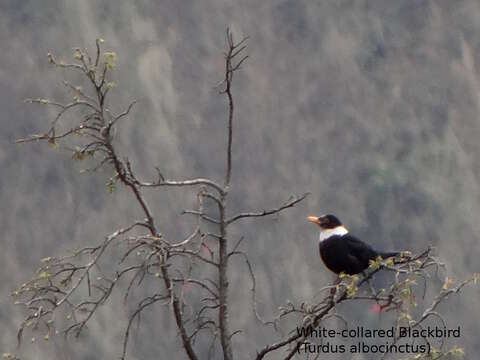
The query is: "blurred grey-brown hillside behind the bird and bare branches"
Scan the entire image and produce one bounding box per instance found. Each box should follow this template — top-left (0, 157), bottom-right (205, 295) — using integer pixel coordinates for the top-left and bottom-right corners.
top-left (0, 0), bottom-right (480, 359)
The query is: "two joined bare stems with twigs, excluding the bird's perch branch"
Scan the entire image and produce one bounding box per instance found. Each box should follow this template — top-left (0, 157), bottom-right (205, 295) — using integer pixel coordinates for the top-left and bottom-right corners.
top-left (14, 30), bottom-right (307, 360)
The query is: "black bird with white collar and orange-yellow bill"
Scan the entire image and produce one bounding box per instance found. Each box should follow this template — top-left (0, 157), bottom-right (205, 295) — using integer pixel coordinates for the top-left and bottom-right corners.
top-left (308, 214), bottom-right (399, 275)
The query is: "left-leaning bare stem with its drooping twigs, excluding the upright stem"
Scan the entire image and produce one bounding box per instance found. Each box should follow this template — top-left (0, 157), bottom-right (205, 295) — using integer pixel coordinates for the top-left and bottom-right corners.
top-left (17, 40), bottom-right (200, 360)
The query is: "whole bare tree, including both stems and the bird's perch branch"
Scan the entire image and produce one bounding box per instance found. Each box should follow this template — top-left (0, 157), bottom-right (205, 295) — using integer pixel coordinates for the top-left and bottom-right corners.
top-left (12, 31), bottom-right (477, 360)
